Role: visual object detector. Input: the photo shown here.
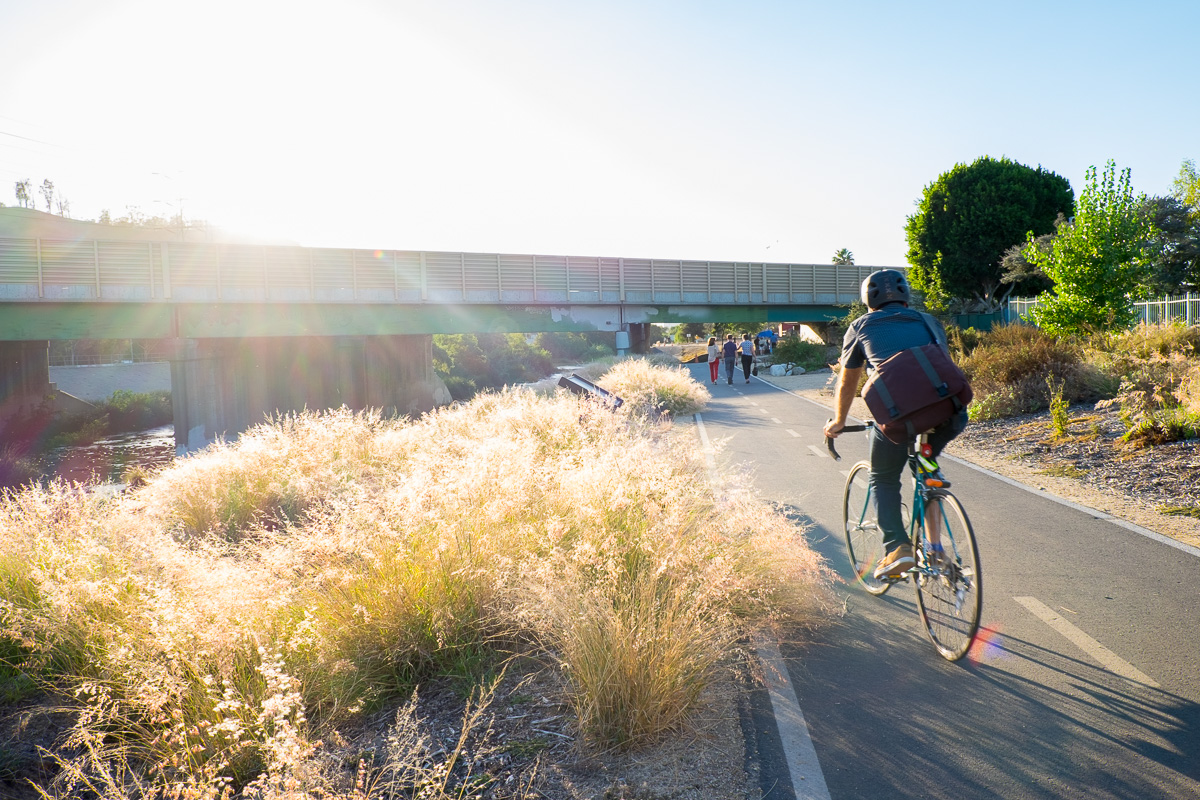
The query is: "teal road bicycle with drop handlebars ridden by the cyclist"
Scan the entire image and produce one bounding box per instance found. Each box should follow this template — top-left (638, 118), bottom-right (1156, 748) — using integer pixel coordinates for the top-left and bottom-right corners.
top-left (826, 422), bottom-right (983, 661)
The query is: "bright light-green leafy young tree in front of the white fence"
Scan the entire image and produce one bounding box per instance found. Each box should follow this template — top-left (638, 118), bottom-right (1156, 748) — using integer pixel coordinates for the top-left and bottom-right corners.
top-left (1025, 160), bottom-right (1154, 336)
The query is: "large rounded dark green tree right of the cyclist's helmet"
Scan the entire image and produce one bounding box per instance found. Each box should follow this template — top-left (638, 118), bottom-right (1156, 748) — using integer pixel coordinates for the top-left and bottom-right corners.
top-left (905, 156), bottom-right (1074, 312)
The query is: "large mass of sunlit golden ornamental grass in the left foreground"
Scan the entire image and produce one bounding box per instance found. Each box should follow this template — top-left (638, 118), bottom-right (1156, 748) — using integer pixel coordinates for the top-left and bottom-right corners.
top-left (0, 367), bottom-right (829, 800)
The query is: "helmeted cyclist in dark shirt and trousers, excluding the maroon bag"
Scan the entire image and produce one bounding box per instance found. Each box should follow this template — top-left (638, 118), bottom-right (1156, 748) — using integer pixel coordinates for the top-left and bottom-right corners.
top-left (824, 270), bottom-right (967, 578)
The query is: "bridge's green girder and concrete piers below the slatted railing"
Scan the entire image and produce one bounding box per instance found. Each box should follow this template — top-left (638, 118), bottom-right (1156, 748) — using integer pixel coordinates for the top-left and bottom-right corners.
top-left (0, 302), bottom-right (845, 452)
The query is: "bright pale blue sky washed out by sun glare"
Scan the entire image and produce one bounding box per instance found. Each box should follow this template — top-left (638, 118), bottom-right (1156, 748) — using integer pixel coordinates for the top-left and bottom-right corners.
top-left (0, 0), bottom-right (1200, 265)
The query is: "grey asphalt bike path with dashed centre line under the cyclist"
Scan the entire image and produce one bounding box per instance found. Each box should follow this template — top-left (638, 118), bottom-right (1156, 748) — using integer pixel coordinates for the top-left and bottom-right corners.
top-left (695, 369), bottom-right (1200, 800)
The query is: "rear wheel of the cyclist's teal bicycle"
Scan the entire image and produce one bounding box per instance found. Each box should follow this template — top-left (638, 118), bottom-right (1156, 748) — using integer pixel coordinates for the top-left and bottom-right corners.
top-left (914, 492), bottom-right (983, 661)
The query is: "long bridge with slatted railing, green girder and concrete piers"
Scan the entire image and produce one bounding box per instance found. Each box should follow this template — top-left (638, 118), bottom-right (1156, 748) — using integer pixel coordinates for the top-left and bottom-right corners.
top-left (0, 209), bottom-right (878, 451)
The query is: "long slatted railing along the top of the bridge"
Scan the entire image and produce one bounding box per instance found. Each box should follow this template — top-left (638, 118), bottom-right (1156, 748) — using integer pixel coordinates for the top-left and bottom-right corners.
top-left (0, 237), bottom-right (880, 305)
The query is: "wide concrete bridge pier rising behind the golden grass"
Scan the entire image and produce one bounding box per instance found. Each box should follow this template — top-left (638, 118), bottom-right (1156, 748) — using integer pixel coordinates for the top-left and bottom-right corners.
top-left (170, 335), bottom-right (450, 455)
